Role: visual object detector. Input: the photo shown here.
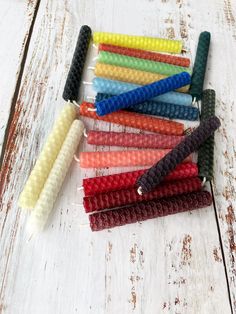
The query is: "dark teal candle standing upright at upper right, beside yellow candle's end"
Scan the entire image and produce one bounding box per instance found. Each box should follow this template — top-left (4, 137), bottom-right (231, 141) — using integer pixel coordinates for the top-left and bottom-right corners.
top-left (189, 32), bottom-right (211, 100)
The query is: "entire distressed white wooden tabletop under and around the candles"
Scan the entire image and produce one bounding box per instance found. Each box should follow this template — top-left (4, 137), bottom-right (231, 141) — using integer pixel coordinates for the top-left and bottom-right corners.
top-left (0, 0), bottom-right (236, 314)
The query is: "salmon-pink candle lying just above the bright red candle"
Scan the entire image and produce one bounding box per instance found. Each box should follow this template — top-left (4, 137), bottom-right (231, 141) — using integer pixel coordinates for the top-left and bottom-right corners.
top-left (79, 149), bottom-right (169, 169)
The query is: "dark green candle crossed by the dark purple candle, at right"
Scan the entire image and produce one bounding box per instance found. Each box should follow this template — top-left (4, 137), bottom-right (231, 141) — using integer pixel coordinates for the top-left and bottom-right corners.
top-left (198, 89), bottom-right (216, 181)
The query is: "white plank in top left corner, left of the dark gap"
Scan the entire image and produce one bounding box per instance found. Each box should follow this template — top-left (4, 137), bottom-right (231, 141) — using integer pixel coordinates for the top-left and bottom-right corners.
top-left (0, 0), bottom-right (38, 156)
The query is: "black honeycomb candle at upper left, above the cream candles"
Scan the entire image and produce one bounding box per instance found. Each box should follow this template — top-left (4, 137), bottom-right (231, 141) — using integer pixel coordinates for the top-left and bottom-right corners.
top-left (63, 25), bottom-right (91, 101)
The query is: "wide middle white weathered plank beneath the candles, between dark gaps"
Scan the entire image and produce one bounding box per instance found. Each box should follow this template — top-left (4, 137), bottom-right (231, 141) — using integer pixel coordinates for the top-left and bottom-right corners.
top-left (0, 0), bottom-right (231, 314)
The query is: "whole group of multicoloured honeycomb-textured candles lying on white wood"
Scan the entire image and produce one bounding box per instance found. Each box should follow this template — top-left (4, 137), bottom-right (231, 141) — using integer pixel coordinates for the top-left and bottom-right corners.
top-left (19, 26), bottom-right (220, 233)
